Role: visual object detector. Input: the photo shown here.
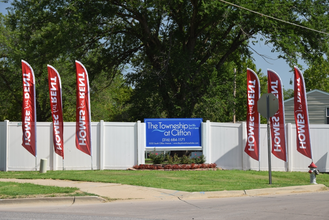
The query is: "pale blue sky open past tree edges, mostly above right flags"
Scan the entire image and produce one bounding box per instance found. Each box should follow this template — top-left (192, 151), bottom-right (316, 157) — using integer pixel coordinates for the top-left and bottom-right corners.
top-left (0, 1), bottom-right (307, 89)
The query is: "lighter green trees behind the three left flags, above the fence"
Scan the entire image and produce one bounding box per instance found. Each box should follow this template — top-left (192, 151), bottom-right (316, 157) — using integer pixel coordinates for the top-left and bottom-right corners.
top-left (0, 11), bottom-right (131, 121)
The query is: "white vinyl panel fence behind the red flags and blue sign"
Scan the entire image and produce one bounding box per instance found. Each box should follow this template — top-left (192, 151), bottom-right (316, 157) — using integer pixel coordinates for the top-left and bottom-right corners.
top-left (0, 121), bottom-right (329, 172)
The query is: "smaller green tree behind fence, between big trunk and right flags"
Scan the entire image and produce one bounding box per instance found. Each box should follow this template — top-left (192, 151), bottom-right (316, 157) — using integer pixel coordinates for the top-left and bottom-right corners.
top-left (193, 57), bottom-right (267, 122)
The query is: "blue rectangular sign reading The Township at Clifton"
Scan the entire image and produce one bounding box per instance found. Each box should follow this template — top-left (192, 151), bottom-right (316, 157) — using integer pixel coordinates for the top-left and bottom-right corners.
top-left (144, 118), bottom-right (202, 147)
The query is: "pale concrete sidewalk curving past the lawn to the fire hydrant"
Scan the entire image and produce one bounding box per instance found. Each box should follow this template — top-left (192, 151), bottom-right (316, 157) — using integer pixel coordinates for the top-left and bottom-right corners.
top-left (0, 179), bottom-right (328, 204)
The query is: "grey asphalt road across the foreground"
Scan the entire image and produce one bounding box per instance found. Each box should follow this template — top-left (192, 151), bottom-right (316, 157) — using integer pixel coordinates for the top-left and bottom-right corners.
top-left (0, 191), bottom-right (329, 220)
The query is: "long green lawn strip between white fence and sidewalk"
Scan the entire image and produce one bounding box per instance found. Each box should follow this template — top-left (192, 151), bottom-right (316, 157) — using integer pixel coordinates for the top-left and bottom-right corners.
top-left (0, 170), bottom-right (329, 194)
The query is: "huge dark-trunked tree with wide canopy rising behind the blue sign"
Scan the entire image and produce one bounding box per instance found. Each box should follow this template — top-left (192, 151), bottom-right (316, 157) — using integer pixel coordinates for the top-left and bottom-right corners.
top-left (0, 0), bottom-right (329, 121)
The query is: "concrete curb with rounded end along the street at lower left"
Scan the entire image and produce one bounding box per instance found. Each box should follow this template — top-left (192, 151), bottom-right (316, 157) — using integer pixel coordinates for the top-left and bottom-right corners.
top-left (0, 196), bottom-right (107, 205)
